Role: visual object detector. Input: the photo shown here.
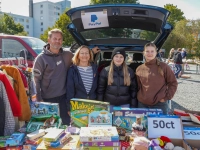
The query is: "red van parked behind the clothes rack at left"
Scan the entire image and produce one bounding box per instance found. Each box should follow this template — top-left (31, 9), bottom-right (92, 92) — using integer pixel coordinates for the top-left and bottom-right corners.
top-left (0, 34), bottom-right (45, 67)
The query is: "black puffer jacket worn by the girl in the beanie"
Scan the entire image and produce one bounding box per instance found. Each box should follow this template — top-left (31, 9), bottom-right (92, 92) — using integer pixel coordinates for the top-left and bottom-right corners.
top-left (97, 66), bottom-right (137, 107)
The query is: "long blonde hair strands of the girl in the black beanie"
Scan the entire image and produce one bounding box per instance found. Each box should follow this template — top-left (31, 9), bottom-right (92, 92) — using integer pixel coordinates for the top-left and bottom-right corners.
top-left (108, 60), bottom-right (131, 86)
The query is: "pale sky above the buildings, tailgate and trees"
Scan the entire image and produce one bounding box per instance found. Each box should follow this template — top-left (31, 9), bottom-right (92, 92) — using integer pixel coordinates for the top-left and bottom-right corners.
top-left (0, 0), bottom-right (200, 20)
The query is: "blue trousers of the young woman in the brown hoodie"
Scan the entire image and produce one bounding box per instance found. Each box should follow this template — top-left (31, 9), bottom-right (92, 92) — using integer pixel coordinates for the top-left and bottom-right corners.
top-left (138, 101), bottom-right (169, 115)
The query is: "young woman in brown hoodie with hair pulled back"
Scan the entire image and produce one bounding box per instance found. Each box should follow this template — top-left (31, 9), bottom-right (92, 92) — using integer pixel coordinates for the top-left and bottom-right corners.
top-left (136, 43), bottom-right (178, 114)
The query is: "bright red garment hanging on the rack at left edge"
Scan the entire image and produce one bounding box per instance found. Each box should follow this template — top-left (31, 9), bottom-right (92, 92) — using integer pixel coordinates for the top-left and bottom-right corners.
top-left (0, 72), bottom-right (21, 117)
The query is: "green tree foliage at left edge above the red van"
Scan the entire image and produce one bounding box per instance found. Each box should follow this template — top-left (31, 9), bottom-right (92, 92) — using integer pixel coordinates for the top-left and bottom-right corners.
top-left (0, 14), bottom-right (27, 35)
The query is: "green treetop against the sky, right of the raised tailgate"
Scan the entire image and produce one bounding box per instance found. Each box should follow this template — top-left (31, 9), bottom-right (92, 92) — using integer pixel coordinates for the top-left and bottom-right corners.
top-left (164, 4), bottom-right (185, 26)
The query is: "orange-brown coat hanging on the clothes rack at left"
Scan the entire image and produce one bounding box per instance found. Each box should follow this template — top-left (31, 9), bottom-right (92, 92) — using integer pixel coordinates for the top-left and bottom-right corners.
top-left (1, 65), bottom-right (31, 121)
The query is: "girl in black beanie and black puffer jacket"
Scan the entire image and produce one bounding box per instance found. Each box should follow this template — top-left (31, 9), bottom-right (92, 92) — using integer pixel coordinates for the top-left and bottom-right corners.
top-left (97, 47), bottom-right (137, 112)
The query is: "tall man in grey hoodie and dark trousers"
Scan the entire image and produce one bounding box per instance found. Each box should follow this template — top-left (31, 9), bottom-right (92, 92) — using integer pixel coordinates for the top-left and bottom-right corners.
top-left (33, 29), bottom-right (99, 125)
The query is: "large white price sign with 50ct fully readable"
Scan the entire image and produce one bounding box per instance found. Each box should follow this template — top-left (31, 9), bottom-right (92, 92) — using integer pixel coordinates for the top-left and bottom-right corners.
top-left (148, 115), bottom-right (183, 139)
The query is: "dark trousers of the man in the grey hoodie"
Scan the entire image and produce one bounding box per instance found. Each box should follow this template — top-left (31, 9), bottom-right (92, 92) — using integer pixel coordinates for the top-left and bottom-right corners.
top-left (43, 94), bottom-right (70, 125)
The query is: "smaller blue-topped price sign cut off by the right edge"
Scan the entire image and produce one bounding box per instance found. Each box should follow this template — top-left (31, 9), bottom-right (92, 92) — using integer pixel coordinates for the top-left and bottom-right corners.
top-left (183, 127), bottom-right (200, 140)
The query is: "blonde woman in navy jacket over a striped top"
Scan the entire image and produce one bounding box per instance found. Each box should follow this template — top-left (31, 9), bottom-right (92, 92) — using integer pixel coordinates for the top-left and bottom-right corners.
top-left (66, 45), bottom-right (98, 111)
